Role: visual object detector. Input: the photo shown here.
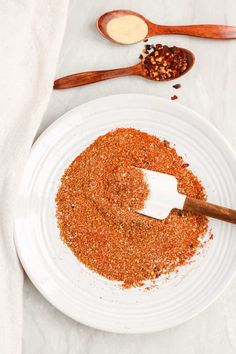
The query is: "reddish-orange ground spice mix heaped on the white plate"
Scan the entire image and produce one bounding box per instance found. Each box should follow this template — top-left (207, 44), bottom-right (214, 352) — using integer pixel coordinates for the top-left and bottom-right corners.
top-left (56, 128), bottom-right (208, 288)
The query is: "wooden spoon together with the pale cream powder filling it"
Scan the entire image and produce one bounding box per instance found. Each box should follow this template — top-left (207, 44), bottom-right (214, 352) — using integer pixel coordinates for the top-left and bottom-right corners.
top-left (97, 10), bottom-right (236, 44)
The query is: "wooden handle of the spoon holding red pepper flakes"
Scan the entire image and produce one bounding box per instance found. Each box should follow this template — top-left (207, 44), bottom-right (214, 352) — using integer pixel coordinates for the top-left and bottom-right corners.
top-left (53, 65), bottom-right (139, 89)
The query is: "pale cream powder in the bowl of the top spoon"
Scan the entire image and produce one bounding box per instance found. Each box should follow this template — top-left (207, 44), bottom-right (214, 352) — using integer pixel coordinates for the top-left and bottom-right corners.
top-left (107, 15), bottom-right (148, 44)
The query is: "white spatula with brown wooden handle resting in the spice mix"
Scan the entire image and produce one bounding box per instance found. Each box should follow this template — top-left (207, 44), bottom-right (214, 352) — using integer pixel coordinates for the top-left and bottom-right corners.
top-left (138, 169), bottom-right (236, 224)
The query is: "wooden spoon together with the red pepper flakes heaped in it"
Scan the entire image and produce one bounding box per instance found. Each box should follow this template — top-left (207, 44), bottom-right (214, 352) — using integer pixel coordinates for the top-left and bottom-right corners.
top-left (54, 44), bottom-right (195, 89)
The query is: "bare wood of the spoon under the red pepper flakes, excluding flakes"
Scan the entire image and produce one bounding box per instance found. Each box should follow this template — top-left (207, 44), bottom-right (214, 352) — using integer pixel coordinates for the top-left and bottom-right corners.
top-left (53, 48), bottom-right (195, 89)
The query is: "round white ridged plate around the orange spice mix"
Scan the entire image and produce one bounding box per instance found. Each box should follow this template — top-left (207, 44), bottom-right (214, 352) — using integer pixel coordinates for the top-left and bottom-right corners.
top-left (15, 94), bottom-right (236, 333)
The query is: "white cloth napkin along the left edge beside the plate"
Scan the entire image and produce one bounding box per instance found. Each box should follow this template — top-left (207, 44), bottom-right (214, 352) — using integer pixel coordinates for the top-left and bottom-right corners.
top-left (0, 0), bottom-right (68, 354)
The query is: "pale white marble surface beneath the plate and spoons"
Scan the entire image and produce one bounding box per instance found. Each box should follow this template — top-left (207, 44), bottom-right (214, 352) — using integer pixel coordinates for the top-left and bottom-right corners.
top-left (23, 0), bottom-right (236, 354)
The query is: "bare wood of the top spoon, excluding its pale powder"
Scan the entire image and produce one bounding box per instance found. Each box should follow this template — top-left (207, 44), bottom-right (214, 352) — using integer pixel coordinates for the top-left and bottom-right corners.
top-left (97, 10), bottom-right (236, 44)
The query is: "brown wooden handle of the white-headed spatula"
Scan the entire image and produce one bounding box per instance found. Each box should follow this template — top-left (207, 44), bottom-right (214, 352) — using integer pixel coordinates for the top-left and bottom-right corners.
top-left (183, 197), bottom-right (236, 224)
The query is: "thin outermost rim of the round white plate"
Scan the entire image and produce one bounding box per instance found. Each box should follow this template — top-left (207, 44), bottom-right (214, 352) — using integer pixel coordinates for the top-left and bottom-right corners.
top-left (14, 93), bottom-right (236, 334)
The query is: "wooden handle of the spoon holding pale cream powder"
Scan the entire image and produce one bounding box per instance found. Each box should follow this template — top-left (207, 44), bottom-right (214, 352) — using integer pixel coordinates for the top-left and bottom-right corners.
top-left (150, 24), bottom-right (236, 39)
